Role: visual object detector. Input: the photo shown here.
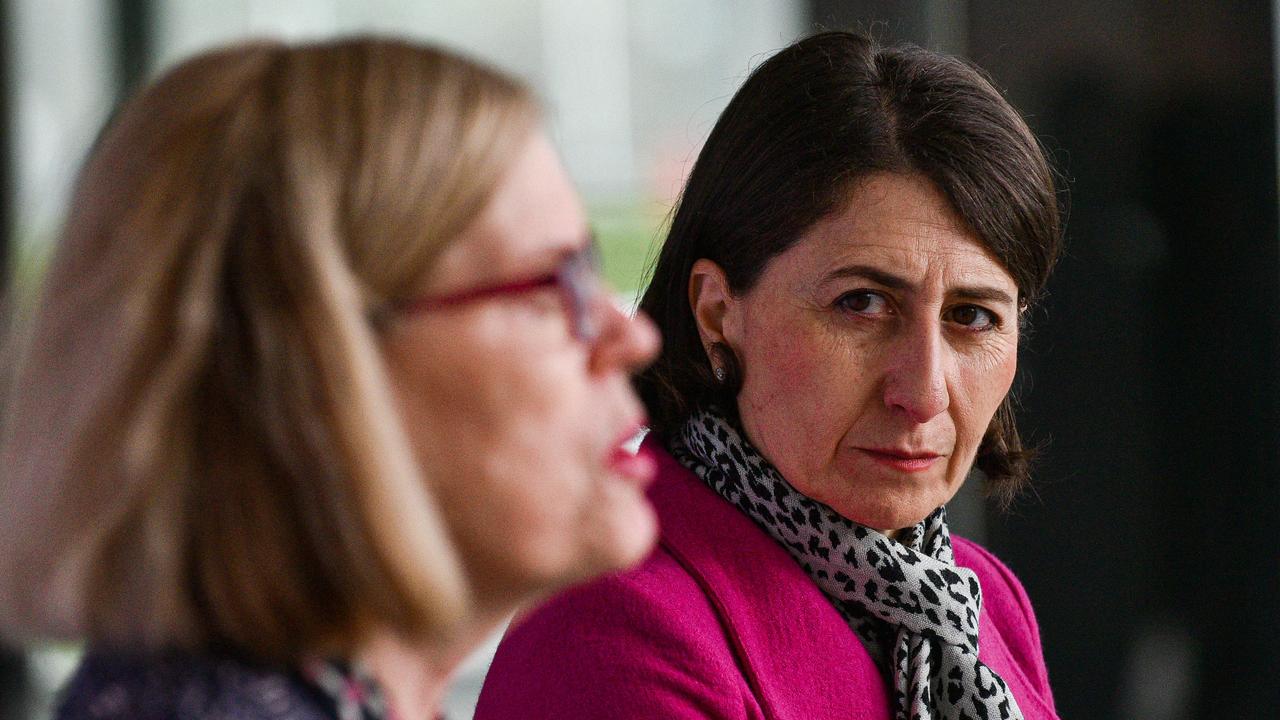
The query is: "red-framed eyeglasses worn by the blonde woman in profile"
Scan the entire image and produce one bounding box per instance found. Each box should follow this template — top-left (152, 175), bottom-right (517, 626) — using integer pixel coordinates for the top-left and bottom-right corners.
top-left (398, 234), bottom-right (602, 345)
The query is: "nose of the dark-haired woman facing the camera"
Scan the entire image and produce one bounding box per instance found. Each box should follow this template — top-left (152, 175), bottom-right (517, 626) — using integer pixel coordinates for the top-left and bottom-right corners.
top-left (884, 327), bottom-right (951, 424)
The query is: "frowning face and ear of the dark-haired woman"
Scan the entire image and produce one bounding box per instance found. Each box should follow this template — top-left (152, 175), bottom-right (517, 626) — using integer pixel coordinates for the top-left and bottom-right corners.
top-left (691, 174), bottom-right (1019, 534)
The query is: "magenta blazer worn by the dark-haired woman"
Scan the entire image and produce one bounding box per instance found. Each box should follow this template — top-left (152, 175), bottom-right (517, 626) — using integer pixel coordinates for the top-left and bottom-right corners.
top-left (475, 438), bottom-right (1057, 720)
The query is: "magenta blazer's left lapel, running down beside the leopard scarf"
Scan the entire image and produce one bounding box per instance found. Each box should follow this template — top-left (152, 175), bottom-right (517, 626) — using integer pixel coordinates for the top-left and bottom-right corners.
top-left (643, 437), bottom-right (890, 720)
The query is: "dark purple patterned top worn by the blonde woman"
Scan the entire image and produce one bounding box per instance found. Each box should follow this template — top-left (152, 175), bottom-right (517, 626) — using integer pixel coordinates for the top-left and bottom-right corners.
top-left (56, 651), bottom-right (390, 720)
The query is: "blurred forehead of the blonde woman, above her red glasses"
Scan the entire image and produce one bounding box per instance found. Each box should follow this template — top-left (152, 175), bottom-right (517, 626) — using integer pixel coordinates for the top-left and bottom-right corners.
top-left (431, 132), bottom-right (586, 287)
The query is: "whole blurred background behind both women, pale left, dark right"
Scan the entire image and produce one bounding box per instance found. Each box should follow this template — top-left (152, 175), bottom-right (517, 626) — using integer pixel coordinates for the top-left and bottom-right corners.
top-left (0, 0), bottom-right (1280, 720)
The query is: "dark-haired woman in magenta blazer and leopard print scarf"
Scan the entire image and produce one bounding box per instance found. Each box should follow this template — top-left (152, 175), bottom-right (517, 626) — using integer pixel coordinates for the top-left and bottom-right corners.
top-left (477, 32), bottom-right (1060, 720)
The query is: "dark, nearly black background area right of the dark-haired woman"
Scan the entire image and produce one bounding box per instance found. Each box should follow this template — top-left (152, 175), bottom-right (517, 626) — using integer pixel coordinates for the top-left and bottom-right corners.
top-left (969, 0), bottom-right (1280, 720)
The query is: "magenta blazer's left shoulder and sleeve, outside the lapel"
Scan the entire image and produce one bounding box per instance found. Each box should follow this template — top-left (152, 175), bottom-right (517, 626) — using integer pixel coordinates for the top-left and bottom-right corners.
top-left (475, 544), bottom-right (756, 720)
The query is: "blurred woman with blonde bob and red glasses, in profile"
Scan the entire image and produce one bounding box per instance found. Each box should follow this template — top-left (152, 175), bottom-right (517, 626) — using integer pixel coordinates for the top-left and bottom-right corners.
top-left (0, 38), bottom-right (657, 720)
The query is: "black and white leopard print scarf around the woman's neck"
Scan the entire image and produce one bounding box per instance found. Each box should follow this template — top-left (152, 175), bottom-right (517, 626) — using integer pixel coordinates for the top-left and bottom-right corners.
top-left (671, 411), bottom-right (1023, 720)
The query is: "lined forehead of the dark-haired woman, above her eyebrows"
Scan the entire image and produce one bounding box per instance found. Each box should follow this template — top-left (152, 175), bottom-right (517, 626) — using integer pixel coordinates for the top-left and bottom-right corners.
top-left (778, 174), bottom-right (1016, 288)
